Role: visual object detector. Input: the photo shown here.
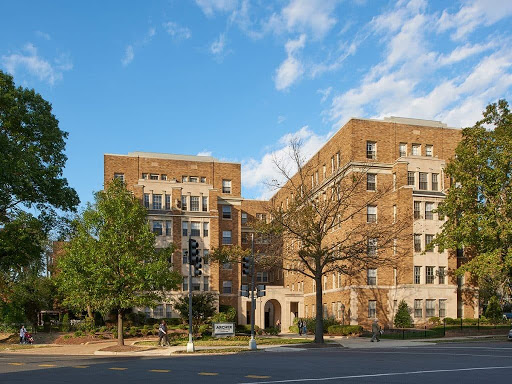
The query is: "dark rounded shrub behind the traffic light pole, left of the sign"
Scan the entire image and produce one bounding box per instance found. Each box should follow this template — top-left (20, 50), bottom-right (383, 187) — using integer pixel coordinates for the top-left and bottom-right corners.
top-left (174, 292), bottom-right (217, 333)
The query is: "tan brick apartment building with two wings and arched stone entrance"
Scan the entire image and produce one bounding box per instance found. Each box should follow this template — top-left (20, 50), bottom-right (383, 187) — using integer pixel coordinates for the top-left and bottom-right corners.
top-left (104, 117), bottom-right (479, 330)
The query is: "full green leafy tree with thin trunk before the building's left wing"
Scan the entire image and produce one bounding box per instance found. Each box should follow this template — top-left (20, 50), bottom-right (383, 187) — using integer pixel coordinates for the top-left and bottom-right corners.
top-left (58, 180), bottom-right (182, 345)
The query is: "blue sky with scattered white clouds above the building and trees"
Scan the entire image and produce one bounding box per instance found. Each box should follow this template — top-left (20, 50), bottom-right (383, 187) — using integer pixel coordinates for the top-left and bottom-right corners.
top-left (0, 0), bottom-right (512, 202)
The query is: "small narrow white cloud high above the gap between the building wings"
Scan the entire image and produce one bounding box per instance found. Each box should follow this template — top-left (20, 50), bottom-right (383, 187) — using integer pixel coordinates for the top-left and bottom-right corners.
top-left (274, 34), bottom-right (306, 91)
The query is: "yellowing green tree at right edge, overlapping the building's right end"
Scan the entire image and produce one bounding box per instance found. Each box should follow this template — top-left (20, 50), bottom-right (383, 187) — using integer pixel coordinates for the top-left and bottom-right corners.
top-left (435, 100), bottom-right (512, 294)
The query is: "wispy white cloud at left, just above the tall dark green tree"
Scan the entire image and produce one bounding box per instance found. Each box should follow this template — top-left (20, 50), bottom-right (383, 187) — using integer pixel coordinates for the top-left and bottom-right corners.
top-left (2, 43), bottom-right (73, 85)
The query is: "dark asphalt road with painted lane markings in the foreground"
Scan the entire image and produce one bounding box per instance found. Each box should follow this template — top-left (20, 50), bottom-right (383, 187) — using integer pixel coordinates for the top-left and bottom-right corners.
top-left (0, 341), bottom-right (512, 384)
